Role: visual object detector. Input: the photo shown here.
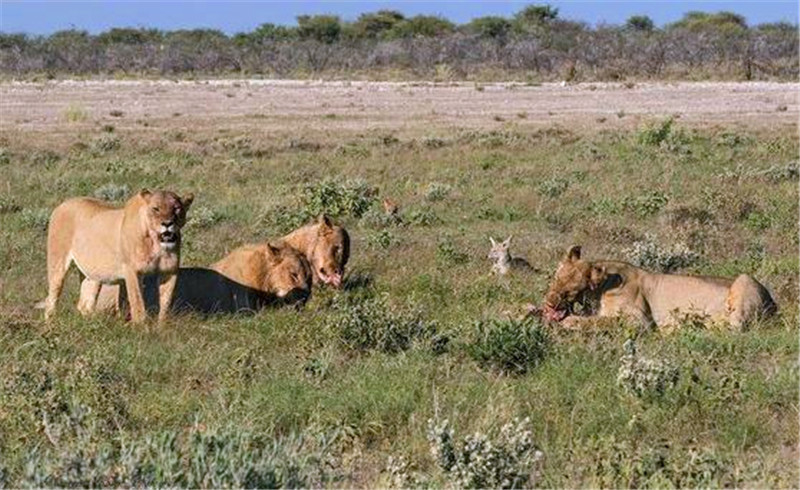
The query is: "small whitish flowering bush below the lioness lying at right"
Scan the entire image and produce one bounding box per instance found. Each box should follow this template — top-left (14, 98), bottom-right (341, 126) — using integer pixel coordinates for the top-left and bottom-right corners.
top-left (617, 339), bottom-right (679, 398)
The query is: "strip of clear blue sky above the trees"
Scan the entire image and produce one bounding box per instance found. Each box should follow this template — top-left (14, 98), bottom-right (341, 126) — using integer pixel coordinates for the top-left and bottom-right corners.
top-left (0, 0), bottom-right (798, 34)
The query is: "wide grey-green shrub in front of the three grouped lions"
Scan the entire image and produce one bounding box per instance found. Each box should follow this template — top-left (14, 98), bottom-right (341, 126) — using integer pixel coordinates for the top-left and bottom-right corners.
top-left (326, 297), bottom-right (437, 353)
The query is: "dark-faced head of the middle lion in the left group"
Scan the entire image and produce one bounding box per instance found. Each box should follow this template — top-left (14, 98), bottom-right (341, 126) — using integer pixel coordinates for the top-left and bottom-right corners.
top-left (262, 242), bottom-right (312, 304)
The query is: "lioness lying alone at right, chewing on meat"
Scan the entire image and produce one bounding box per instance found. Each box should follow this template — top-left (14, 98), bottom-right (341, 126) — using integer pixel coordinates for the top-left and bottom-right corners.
top-left (542, 246), bottom-right (777, 329)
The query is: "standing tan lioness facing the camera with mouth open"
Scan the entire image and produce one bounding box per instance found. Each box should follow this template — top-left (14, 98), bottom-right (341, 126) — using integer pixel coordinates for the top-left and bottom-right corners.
top-left (45, 189), bottom-right (194, 322)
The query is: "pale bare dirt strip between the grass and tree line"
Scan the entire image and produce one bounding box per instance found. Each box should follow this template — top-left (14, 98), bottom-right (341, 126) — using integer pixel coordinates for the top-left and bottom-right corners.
top-left (0, 80), bottom-right (800, 145)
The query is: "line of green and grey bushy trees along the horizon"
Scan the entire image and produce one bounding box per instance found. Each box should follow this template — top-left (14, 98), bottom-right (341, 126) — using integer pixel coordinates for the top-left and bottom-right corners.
top-left (0, 5), bottom-right (798, 81)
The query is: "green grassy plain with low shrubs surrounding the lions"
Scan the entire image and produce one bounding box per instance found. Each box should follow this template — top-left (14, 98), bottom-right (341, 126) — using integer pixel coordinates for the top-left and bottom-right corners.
top-left (0, 81), bottom-right (798, 487)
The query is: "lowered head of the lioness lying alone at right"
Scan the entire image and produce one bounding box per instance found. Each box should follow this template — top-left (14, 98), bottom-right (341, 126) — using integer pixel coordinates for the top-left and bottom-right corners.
top-left (544, 245), bottom-right (605, 321)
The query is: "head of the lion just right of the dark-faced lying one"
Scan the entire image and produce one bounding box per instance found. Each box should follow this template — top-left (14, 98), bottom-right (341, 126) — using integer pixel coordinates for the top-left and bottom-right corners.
top-left (310, 215), bottom-right (350, 288)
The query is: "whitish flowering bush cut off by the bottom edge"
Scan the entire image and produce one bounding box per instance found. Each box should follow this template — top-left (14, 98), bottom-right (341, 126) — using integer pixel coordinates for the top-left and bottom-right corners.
top-left (428, 418), bottom-right (544, 488)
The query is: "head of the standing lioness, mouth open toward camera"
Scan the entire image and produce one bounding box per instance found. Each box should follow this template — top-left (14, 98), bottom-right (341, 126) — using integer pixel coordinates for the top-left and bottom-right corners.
top-left (139, 189), bottom-right (194, 249)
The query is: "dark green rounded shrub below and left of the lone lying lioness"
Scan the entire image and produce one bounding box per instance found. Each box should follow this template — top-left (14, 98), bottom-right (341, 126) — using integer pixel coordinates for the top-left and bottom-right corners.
top-left (466, 319), bottom-right (550, 375)
